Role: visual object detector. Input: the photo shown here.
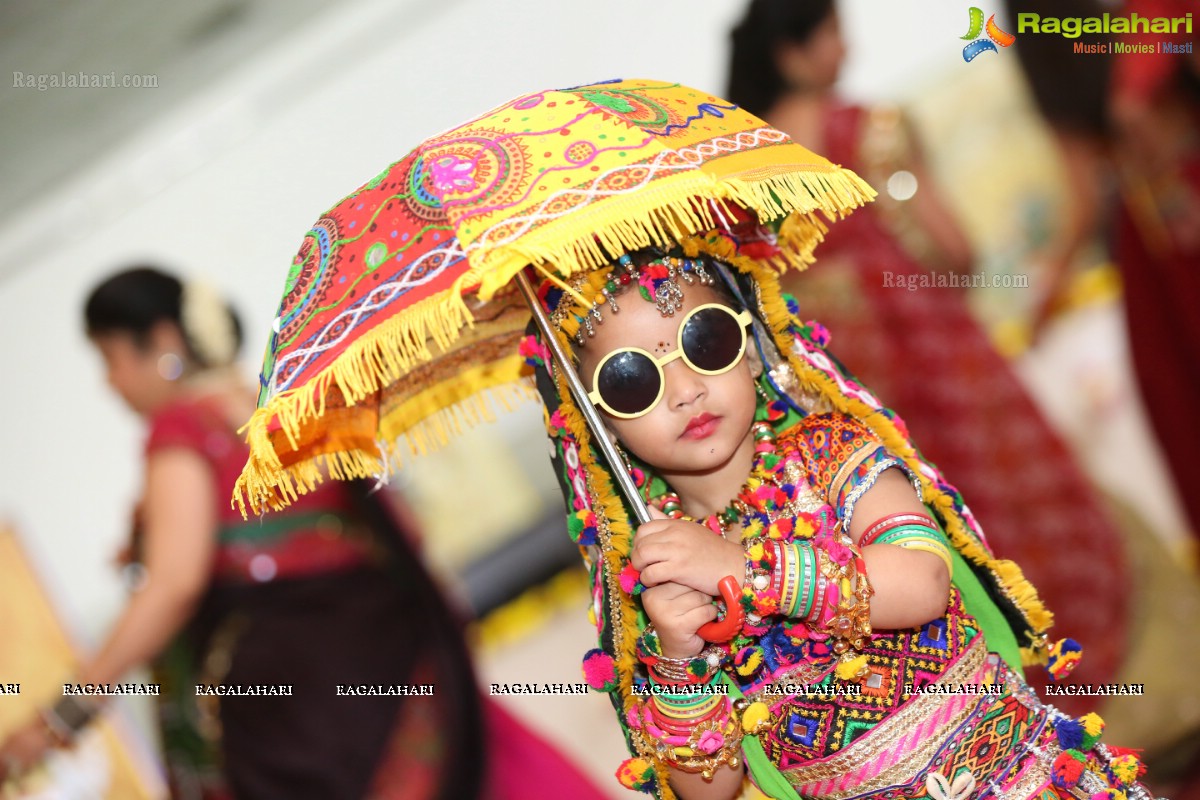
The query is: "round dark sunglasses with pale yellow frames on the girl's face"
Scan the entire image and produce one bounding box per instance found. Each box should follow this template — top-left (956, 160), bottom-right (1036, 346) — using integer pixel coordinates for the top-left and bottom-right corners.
top-left (588, 302), bottom-right (754, 420)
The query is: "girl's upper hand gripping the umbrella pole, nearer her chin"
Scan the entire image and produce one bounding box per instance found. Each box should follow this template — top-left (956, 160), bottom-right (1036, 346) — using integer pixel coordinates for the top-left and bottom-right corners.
top-left (630, 506), bottom-right (745, 596)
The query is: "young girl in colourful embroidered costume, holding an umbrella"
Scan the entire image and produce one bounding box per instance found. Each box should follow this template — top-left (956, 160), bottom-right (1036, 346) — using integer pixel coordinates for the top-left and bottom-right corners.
top-left (526, 247), bottom-right (1148, 800)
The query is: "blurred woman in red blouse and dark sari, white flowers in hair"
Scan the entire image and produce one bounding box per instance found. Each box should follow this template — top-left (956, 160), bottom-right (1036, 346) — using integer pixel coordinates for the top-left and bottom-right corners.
top-left (0, 267), bottom-right (485, 800)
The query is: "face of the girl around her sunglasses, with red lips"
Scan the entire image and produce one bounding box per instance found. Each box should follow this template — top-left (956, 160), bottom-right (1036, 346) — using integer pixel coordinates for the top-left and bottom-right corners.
top-left (578, 284), bottom-right (762, 474)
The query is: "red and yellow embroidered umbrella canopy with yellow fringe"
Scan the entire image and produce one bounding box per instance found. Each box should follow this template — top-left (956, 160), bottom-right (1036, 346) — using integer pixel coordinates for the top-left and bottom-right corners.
top-left (235, 80), bottom-right (874, 512)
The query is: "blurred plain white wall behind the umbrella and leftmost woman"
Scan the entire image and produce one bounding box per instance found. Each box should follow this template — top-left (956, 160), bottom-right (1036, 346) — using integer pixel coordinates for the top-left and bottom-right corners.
top-left (0, 0), bottom-right (968, 642)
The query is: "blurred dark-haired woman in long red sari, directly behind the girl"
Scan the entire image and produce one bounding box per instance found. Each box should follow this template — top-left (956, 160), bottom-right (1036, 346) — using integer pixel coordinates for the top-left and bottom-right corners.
top-left (728, 0), bottom-right (1129, 714)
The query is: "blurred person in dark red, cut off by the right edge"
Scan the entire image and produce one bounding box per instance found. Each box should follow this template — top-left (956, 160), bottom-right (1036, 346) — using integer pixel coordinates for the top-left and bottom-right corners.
top-left (1008, 0), bottom-right (1200, 551)
